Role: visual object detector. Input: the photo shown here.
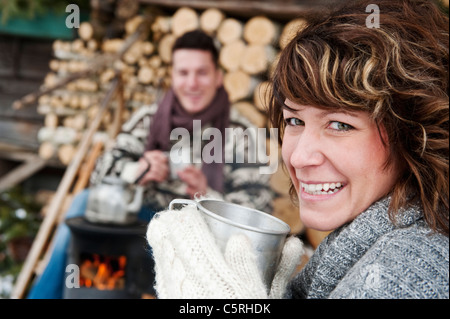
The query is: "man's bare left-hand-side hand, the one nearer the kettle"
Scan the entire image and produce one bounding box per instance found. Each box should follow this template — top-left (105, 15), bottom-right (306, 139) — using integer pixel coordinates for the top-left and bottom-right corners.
top-left (138, 150), bottom-right (169, 185)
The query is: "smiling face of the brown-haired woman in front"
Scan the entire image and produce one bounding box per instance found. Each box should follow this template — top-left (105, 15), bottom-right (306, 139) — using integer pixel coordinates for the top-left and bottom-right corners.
top-left (282, 100), bottom-right (397, 231)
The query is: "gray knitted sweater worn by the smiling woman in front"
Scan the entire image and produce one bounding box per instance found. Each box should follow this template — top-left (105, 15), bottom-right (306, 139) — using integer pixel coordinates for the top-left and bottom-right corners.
top-left (286, 198), bottom-right (449, 299)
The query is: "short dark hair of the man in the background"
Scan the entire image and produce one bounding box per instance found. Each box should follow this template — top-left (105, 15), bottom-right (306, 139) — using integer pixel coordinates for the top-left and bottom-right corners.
top-left (172, 30), bottom-right (219, 66)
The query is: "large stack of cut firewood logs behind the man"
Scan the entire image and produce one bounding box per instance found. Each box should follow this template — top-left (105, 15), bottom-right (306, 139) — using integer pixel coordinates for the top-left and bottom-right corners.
top-left (34, 7), bottom-right (305, 232)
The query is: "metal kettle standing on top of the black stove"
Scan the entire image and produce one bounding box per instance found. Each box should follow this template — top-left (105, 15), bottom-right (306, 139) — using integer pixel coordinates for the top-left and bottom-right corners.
top-left (85, 176), bottom-right (144, 224)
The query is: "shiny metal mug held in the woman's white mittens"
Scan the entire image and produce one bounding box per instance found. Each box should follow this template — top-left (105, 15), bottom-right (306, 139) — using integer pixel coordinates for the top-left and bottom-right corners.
top-left (169, 199), bottom-right (291, 290)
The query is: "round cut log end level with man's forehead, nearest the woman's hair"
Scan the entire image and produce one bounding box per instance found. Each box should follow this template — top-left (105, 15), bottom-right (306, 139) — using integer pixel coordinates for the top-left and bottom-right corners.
top-left (240, 44), bottom-right (276, 74)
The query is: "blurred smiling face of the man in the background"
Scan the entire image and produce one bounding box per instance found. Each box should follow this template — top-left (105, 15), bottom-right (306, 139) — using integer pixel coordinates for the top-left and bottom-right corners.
top-left (172, 49), bottom-right (222, 114)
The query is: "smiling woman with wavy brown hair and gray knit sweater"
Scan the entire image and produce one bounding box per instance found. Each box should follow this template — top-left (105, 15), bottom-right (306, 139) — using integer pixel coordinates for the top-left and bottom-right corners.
top-left (270, 0), bottom-right (449, 298)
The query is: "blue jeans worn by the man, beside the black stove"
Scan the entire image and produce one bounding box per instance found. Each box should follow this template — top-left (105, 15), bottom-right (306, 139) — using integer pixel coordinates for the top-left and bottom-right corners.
top-left (27, 189), bottom-right (155, 299)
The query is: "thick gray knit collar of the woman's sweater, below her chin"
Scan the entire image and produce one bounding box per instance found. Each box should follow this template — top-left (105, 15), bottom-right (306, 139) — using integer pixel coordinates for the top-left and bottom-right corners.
top-left (308, 197), bottom-right (423, 299)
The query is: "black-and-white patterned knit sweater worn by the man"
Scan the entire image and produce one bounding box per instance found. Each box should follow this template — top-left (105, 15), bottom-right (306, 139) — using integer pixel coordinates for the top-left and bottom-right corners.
top-left (90, 103), bottom-right (276, 212)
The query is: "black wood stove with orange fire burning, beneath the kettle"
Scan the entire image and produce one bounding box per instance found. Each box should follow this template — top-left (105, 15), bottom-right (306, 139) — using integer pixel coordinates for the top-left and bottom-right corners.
top-left (63, 217), bottom-right (155, 299)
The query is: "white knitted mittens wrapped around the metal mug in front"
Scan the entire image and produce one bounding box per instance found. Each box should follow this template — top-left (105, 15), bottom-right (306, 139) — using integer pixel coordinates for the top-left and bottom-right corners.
top-left (147, 205), bottom-right (303, 299)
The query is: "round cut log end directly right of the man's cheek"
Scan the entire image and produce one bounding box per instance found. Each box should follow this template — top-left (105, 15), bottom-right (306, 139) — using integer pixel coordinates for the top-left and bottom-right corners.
top-left (223, 70), bottom-right (260, 102)
